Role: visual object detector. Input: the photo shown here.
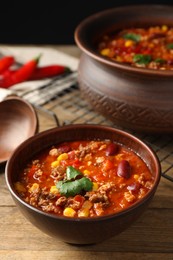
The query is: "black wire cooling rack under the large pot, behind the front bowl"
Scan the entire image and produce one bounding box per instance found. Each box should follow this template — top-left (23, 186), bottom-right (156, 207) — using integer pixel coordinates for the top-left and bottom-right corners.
top-left (20, 72), bottom-right (173, 182)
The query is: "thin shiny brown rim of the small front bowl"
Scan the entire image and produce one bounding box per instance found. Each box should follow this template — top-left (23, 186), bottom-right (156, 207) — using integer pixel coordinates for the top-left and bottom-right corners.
top-left (5, 124), bottom-right (161, 222)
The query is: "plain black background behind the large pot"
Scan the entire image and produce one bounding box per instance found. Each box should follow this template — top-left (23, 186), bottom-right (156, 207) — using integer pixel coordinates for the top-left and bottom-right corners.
top-left (0, 0), bottom-right (173, 45)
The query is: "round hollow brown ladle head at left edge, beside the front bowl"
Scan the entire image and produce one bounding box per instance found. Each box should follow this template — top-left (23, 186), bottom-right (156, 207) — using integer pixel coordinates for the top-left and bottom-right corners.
top-left (0, 95), bottom-right (38, 164)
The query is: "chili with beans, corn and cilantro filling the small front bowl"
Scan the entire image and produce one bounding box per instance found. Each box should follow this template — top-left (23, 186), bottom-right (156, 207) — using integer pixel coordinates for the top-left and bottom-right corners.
top-left (15, 140), bottom-right (154, 218)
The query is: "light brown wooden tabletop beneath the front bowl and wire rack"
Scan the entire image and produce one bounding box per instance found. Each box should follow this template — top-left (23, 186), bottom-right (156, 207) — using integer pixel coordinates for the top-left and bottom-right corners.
top-left (0, 46), bottom-right (173, 260)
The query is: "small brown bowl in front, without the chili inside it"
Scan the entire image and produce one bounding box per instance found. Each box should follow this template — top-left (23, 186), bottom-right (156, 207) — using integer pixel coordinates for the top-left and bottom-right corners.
top-left (5, 125), bottom-right (161, 244)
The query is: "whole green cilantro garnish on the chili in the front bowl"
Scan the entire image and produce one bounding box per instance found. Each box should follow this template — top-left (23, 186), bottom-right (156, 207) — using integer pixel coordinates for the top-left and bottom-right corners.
top-left (56, 166), bottom-right (93, 197)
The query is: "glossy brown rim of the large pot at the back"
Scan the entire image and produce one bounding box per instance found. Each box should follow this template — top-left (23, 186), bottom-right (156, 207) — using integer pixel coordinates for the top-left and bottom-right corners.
top-left (74, 4), bottom-right (173, 78)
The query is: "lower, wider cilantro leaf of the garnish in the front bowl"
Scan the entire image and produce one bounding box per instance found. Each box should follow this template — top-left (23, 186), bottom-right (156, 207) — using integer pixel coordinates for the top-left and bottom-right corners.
top-left (56, 177), bottom-right (93, 197)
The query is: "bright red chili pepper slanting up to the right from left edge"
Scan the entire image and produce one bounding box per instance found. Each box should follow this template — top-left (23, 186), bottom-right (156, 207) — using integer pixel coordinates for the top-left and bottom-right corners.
top-left (0, 56), bottom-right (40, 88)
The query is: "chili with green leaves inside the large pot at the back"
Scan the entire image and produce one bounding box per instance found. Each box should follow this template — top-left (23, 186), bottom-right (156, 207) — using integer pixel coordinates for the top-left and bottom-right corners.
top-left (98, 25), bottom-right (173, 70)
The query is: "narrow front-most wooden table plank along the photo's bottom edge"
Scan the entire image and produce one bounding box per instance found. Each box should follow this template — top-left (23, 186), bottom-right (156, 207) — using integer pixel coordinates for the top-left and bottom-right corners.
top-left (0, 250), bottom-right (173, 260)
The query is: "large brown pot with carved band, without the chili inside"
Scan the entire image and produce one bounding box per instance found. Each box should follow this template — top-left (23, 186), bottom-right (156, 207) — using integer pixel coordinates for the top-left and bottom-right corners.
top-left (74, 5), bottom-right (173, 133)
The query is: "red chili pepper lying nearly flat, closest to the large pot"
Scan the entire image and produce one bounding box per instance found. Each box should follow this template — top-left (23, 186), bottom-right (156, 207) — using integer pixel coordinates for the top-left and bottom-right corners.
top-left (29, 64), bottom-right (70, 80)
